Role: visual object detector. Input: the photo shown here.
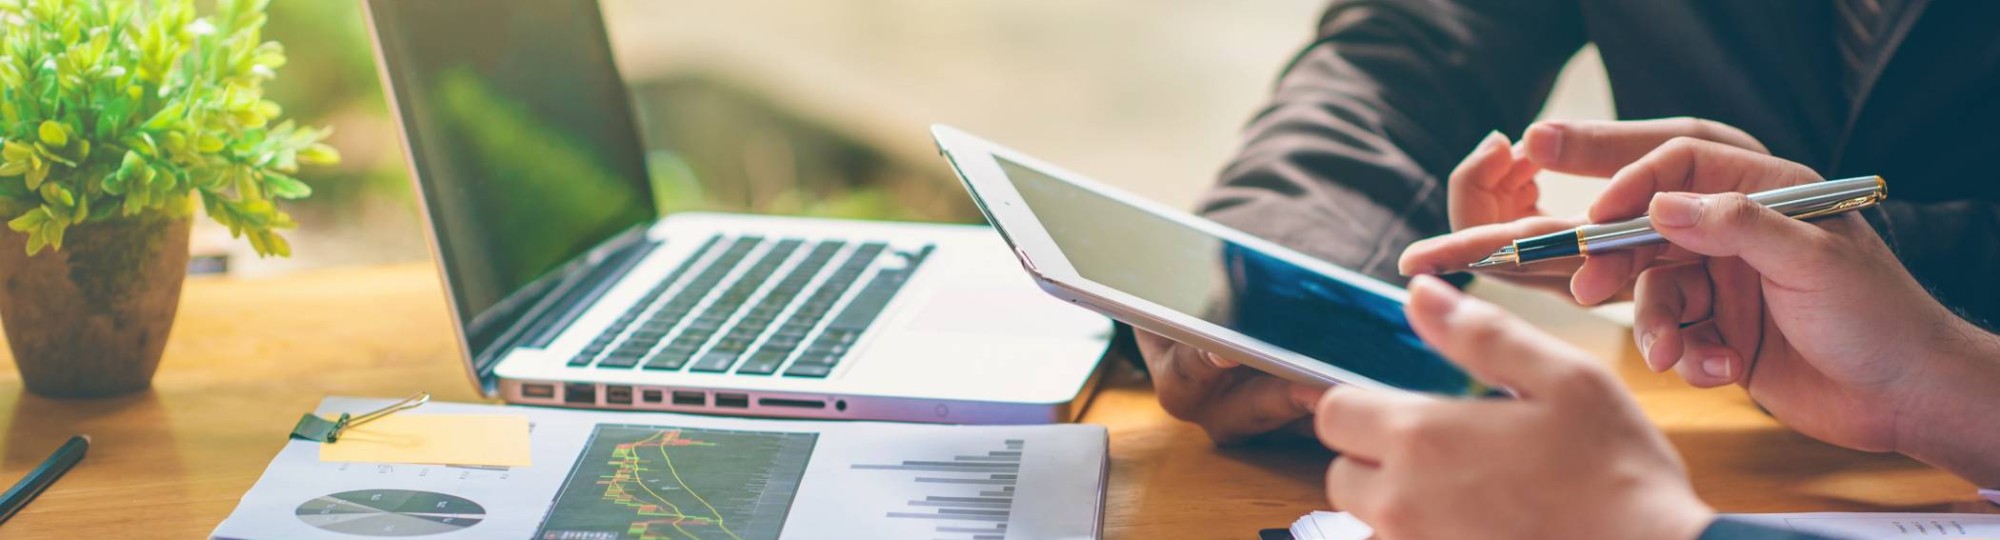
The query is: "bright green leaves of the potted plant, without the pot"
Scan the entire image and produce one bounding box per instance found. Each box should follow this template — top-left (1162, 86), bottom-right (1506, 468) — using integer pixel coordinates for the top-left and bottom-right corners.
top-left (0, 0), bottom-right (340, 256)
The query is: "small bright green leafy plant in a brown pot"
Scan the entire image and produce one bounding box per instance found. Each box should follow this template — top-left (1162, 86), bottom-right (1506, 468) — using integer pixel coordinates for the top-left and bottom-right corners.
top-left (0, 0), bottom-right (340, 396)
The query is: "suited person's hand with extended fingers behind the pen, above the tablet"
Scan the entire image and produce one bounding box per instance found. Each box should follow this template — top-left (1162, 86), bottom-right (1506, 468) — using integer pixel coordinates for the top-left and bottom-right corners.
top-left (1398, 118), bottom-right (1766, 304)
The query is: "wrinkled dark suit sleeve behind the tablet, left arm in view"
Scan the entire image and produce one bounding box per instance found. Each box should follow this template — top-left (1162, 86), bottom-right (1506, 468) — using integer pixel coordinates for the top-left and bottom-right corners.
top-left (1202, 0), bottom-right (1586, 282)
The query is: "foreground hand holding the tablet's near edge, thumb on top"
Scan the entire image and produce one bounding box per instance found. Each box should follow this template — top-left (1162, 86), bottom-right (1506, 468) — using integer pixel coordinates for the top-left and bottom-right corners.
top-left (1316, 276), bottom-right (1712, 540)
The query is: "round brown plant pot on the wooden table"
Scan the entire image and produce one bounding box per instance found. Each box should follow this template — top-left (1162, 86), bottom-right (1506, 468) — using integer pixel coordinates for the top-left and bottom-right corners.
top-left (0, 214), bottom-right (190, 398)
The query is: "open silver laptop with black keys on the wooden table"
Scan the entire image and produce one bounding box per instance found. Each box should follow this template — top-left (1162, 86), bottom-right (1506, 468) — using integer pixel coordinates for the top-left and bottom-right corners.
top-left (364, 0), bottom-right (1112, 424)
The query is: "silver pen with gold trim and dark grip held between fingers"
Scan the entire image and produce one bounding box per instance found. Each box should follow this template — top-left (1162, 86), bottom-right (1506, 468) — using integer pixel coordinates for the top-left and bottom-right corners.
top-left (1470, 176), bottom-right (1888, 268)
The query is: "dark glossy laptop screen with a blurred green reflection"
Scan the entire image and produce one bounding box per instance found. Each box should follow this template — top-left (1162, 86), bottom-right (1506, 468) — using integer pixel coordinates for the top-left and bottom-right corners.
top-left (368, 0), bottom-right (656, 358)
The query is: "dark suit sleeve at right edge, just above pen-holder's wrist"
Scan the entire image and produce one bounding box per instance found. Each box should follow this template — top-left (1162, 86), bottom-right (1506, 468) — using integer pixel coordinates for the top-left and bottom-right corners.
top-left (1870, 200), bottom-right (2000, 330)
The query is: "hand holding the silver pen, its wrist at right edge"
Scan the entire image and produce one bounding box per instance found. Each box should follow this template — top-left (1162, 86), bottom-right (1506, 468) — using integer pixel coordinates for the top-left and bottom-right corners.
top-left (1590, 142), bottom-right (1992, 464)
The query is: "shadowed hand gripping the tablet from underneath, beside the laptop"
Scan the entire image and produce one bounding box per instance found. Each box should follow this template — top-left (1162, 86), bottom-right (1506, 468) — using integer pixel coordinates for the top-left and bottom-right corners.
top-left (1134, 330), bottom-right (1320, 444)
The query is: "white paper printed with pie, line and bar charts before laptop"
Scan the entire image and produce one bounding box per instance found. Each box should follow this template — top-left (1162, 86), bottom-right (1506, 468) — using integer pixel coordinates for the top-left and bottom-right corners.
top-left (214, 398), bottom-right (1106, 540)
